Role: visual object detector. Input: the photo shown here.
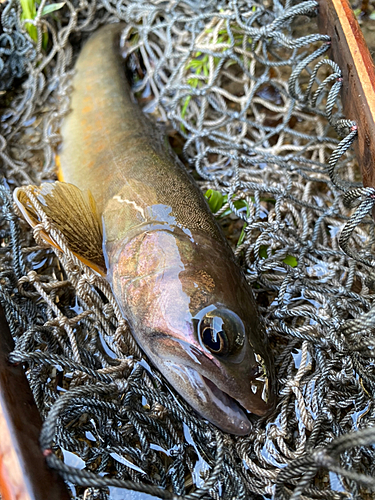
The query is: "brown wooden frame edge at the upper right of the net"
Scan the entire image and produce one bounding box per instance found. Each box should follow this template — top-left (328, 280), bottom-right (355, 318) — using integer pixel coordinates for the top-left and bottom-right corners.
top-left (318, 0), bottom-right (375, 187)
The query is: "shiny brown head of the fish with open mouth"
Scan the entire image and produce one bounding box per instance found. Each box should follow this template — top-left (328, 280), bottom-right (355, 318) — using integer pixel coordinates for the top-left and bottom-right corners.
top-left (108, 230), bottom-right (275, 435)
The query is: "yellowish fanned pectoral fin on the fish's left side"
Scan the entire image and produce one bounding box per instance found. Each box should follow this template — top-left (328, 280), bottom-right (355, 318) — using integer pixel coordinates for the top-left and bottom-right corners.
top-left (13, 181), bottom-right (105, 275)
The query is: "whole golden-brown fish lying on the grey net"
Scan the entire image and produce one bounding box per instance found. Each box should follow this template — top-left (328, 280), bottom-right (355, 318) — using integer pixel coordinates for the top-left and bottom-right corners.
top-left (14, 23), bottom-right (276, 435)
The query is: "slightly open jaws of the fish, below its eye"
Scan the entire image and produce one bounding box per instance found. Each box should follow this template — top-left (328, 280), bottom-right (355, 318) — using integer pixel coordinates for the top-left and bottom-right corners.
top-left (137, 334), bottom-right (273, 436)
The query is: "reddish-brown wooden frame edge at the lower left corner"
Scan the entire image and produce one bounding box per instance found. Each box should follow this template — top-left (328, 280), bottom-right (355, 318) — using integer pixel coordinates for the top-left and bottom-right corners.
top-left (0, 307), bottom-right (70, 500)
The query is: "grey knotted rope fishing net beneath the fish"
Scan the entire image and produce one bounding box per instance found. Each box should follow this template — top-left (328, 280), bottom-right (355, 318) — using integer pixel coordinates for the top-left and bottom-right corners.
top-left (0, 0), bottom-right (375, 500)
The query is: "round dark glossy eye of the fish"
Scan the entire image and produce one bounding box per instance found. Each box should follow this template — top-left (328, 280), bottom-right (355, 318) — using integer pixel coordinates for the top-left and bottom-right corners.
top-left (197, 306), bottom-right (245, 356)
